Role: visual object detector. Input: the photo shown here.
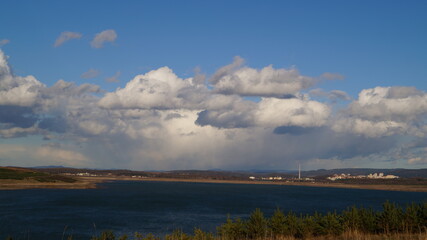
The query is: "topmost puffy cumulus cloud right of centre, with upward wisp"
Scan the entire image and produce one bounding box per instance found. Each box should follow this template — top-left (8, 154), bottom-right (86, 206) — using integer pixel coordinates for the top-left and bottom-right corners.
top-left (209, 57), bottom-right (317, 98)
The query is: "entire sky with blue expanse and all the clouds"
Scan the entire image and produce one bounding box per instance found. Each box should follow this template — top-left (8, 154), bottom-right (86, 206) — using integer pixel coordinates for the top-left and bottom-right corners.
top-left (0, 0), bottom-right (427, 170)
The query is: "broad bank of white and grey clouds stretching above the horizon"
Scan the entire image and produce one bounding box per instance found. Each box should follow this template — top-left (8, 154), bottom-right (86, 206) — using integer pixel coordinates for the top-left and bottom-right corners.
top-left (0, 49), bottom-right (427, 170)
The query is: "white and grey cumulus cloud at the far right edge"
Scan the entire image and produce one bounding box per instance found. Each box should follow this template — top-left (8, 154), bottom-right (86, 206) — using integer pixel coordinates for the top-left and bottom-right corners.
top-left (332, 87), bottom-right (427, 137)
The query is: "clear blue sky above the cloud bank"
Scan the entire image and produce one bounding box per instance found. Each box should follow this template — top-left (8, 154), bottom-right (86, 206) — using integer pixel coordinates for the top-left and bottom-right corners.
top-left (4, 1), bottom-right (427, 94)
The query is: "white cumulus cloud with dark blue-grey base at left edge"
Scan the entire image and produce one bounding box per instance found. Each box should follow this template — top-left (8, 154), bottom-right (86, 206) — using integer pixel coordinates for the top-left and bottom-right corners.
top-left (0, 51), bottom-right (104, 142)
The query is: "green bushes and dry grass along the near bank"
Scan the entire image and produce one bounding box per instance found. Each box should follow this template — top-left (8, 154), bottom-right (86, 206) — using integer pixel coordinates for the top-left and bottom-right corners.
top-left (7, 202), bottom-right (427, 240)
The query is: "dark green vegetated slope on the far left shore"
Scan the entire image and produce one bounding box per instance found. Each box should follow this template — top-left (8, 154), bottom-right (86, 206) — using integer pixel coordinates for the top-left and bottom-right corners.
top-left (0, 168), bottom-right (76, 183)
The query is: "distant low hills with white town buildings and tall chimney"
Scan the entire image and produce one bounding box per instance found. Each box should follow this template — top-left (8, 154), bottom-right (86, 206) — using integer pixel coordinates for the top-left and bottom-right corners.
top-left (37, 167), bottom-right (427, 185)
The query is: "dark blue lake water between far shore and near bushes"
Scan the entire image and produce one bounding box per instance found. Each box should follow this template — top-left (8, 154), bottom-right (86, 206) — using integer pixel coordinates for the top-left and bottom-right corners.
top-left (0, 181), bottom-right (427, 240)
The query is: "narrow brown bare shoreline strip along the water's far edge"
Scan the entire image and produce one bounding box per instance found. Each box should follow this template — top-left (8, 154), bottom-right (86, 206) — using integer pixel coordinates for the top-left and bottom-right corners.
top-left (0, 176), bottom-right (427, 192)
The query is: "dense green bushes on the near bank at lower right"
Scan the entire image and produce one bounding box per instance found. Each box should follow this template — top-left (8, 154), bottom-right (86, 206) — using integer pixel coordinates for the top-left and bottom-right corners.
top-left (218, 202), bottom-right (427, 240)
